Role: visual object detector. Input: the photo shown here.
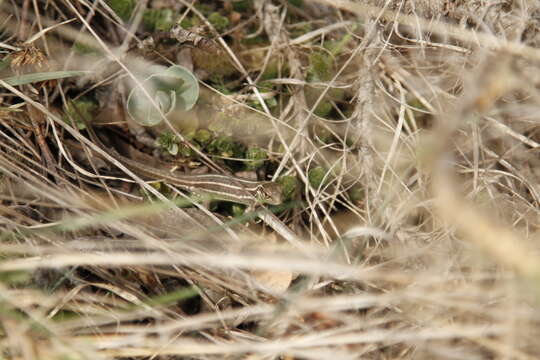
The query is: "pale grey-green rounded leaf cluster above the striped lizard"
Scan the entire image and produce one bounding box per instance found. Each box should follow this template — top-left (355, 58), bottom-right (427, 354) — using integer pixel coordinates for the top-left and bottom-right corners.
top-left (127, 65), bottom-right (199, 126)
